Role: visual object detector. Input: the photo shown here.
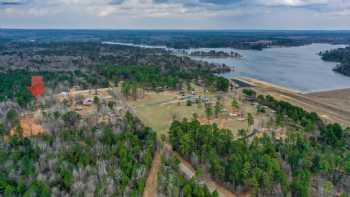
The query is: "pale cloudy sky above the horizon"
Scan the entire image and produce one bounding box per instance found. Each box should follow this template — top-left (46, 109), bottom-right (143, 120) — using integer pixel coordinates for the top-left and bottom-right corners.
top-left (0, 0), bottom-right (350, 30)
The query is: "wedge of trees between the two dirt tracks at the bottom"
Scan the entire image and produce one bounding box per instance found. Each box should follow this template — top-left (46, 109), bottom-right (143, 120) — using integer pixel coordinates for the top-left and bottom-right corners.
top-left (157, 154), bottom-right (219, 197)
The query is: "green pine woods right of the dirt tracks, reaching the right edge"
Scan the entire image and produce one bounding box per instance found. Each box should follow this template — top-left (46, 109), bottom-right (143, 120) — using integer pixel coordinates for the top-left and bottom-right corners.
top-left (170, 92), bottom-right (350, 197)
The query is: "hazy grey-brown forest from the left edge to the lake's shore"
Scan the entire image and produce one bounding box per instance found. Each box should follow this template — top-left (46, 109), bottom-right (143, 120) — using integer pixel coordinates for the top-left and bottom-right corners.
top-left (0, 42), bottom-right (230, 73)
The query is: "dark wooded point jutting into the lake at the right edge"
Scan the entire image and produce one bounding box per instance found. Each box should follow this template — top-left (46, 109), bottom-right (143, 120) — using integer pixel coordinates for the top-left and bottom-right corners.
top-left (320, 47), bottom-right (350, 76)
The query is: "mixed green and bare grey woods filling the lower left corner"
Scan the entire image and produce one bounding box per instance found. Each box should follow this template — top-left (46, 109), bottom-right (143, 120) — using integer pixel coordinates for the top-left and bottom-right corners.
top-left (0, 112), bottom-right (156, 197)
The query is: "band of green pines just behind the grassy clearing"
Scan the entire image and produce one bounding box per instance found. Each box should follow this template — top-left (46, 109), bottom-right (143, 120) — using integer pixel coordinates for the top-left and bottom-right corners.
top-left (100, 65), bottom-right (229, 91)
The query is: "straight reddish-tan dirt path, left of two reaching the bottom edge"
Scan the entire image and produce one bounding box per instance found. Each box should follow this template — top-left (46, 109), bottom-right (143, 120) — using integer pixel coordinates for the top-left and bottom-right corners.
top-left (143, 150), bottom-right (160, 197)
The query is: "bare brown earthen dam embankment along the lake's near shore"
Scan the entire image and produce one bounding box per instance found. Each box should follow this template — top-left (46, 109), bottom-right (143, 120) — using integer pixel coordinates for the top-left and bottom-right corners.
top-left (237, 77), bottom-right (350, 126)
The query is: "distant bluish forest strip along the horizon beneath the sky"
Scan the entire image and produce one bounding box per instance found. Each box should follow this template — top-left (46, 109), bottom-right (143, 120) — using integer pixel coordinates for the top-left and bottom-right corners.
top-left (0, 29), bottom-right (350, 49)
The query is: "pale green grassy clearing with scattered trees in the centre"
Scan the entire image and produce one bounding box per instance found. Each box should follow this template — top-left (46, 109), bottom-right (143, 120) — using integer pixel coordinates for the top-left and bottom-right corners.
top-left (128, 87), bottom-right (263, 136)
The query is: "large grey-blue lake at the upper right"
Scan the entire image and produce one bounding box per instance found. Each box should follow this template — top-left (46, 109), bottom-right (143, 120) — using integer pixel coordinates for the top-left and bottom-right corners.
top-left (190, 44), bottom-right (350, 92)
